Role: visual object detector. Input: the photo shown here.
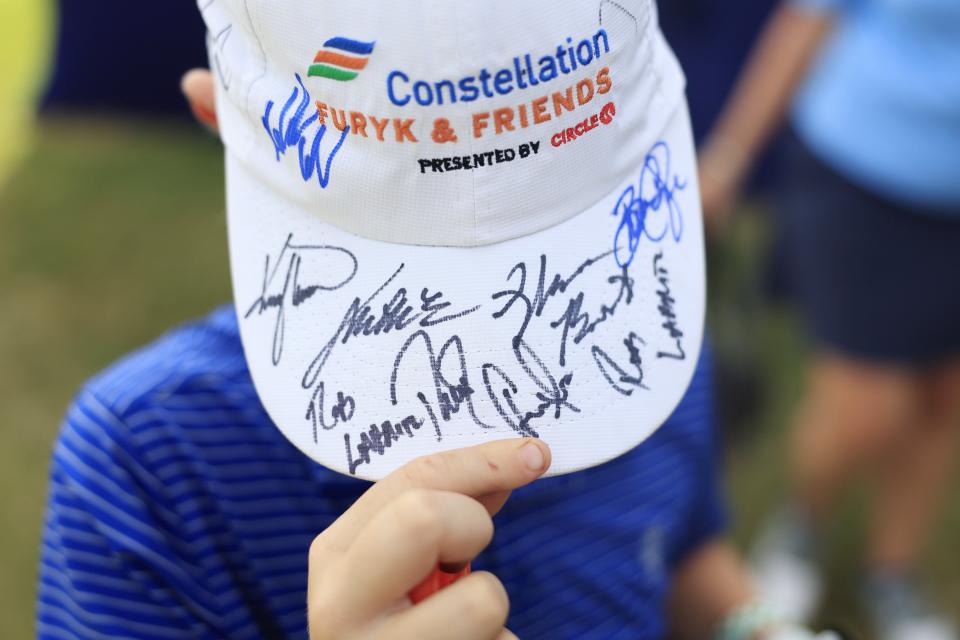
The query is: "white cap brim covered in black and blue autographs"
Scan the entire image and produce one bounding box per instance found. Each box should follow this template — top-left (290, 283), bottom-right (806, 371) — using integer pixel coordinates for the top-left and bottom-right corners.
top-left (227, 106), bottom-right (705, 480)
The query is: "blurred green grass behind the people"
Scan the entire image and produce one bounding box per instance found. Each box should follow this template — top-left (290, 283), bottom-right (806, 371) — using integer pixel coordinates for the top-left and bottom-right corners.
top-left (0, 0), bottom-right (960, 639)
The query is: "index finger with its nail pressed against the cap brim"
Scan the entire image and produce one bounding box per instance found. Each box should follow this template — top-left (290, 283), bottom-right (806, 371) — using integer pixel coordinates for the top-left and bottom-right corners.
top-left (318, 438), bottom-right (550, 553)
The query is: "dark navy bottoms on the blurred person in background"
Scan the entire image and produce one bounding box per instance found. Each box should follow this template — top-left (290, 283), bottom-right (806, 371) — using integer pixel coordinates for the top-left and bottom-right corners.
top-left (778, 133), bottom-right (960, 366)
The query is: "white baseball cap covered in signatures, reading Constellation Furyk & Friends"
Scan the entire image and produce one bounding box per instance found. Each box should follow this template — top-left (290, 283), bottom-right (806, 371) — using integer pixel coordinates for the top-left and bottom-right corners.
top-left (199, 0), bottom-right (705, 479)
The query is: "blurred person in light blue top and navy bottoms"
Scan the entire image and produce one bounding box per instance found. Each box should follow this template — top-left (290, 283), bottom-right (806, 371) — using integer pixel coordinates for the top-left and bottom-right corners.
top-left (700, 0), bottom-right (960, 640)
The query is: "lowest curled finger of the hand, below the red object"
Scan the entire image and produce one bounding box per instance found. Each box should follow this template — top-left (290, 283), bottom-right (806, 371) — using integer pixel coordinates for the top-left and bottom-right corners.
top-left (377, 571), bottom-right (513, 640)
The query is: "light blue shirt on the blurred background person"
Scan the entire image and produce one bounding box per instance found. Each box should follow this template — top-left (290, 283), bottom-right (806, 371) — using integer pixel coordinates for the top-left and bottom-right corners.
top-left (793, 0), bottom-right (960, 217)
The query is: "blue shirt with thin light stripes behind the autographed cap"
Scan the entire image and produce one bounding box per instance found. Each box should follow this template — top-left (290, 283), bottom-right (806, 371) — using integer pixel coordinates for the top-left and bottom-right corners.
top-left (37, 309), bottom-right (724, 640)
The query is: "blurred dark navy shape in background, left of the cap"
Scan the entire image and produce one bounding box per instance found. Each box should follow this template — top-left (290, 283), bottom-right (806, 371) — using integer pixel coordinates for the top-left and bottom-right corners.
top-left (41, 0), bottom-right (207, 116)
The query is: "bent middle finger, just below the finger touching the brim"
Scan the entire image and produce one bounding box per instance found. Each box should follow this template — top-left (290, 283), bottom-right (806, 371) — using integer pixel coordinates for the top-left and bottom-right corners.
top-left (328, 489), bottom-right (493, 622)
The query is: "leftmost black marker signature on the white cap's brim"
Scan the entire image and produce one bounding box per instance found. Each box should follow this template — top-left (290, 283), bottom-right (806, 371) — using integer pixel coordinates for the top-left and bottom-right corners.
top-left (244, 233), bottom-right (359, 366)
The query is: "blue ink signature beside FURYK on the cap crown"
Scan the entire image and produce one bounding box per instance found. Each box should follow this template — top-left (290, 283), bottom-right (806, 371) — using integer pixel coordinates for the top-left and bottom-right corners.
top-left (262, 74), bottom-right (350, 189)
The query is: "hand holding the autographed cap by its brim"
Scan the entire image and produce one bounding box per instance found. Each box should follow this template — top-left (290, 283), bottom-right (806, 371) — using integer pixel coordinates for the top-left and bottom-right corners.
top-left (307, 439), bottom-right (550, 640)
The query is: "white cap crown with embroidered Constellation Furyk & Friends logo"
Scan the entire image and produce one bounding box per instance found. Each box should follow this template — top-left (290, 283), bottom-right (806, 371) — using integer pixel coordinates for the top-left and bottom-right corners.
top-left (199, 0), bottom-right (683, 246)
